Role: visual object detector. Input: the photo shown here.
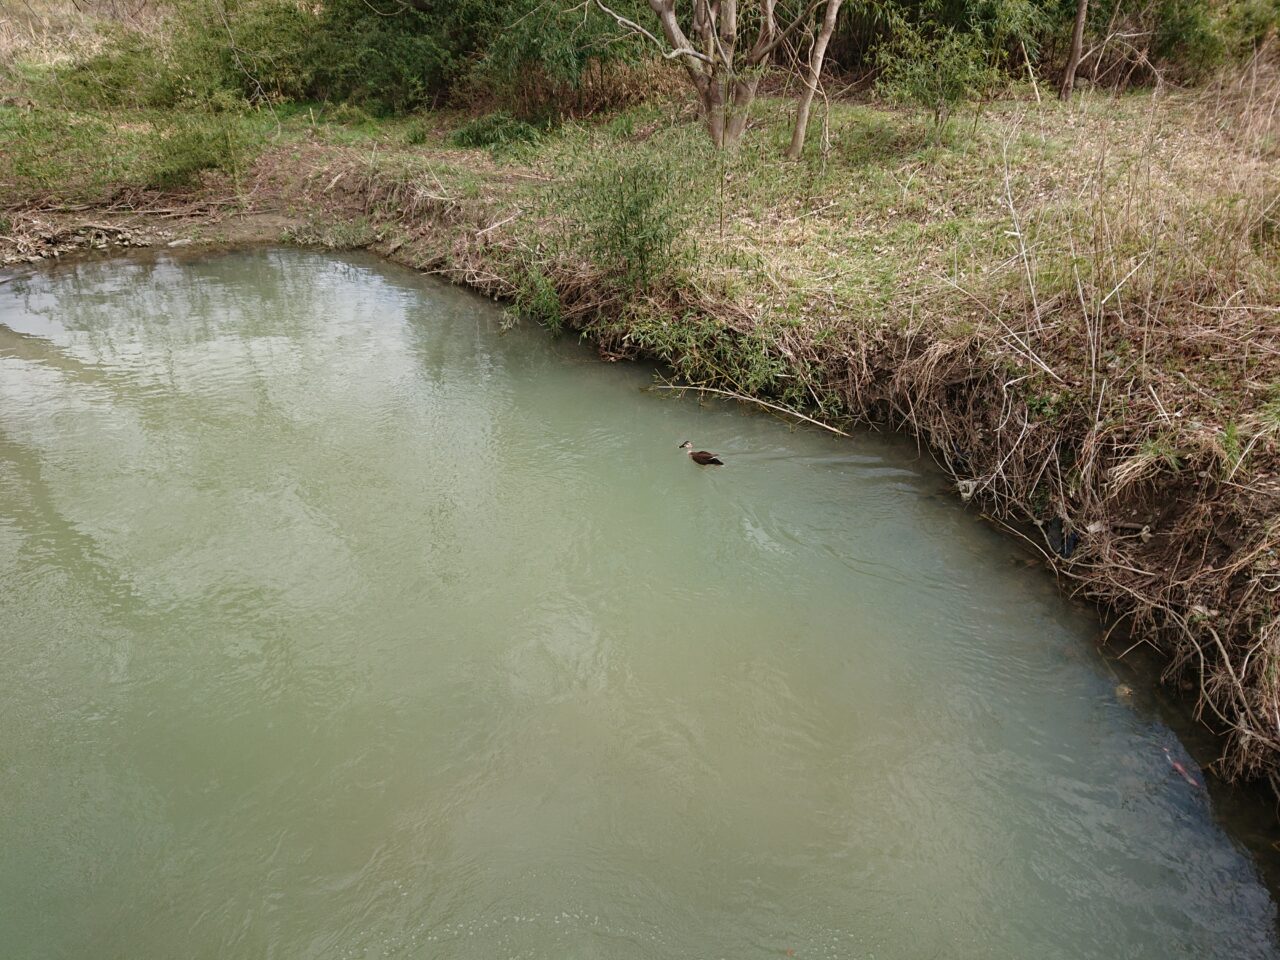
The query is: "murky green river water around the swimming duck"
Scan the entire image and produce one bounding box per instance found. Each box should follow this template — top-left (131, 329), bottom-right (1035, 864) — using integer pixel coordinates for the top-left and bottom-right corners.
top-left (0, 251), bottom-right (1280, 960)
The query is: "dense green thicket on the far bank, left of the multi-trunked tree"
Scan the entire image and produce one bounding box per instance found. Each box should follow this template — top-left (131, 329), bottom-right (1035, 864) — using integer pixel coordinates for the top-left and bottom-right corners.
top-left (42, 0), bottom-right (649, 116)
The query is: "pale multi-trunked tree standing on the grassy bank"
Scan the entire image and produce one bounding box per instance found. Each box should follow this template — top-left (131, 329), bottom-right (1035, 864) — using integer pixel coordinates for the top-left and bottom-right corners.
top-left (595, 0), bottom-right (838, 148)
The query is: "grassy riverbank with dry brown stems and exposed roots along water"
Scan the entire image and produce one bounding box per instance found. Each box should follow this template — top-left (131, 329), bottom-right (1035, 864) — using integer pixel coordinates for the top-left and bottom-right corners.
top-left (0, 52), bottom-right (1280, 798)
